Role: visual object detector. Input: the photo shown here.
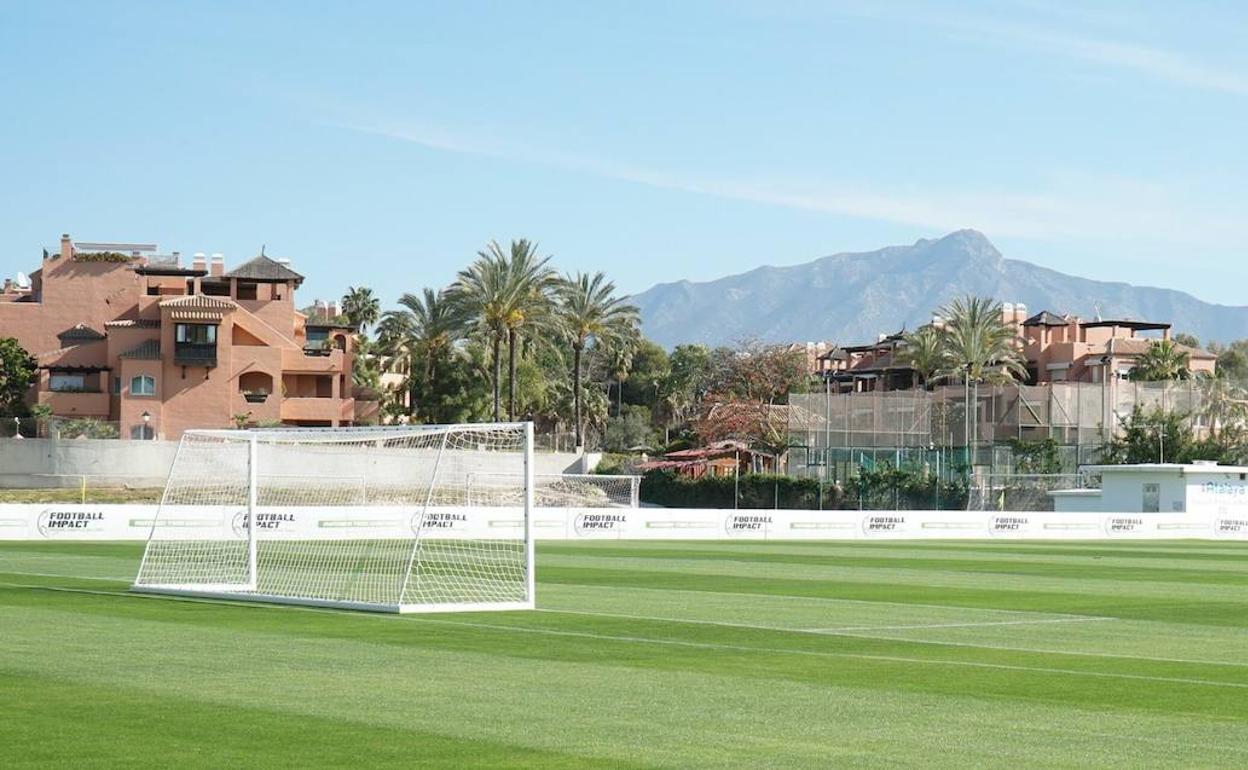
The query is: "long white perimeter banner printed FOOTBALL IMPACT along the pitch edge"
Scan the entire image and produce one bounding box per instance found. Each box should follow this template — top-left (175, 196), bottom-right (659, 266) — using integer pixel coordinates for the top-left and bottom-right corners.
top-left (0, 504), bottom-right (1248, 540)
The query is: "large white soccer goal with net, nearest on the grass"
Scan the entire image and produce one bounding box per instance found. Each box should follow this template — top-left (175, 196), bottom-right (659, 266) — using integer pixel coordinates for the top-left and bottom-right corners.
top-left (132, 423), bottom-right (534, 613)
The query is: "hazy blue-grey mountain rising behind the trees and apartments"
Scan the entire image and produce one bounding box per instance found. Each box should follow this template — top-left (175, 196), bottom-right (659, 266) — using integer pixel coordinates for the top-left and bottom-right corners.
top-left (633, 230), bottom-right (1248, 347)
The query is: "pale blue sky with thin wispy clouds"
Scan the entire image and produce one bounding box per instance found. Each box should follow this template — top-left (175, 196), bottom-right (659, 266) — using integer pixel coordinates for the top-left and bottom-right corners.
top-left (0, 0), bottom-right (1248, 309)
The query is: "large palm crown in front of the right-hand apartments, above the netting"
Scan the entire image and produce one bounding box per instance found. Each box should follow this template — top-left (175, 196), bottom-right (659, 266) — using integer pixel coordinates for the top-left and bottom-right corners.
top-left (940, 296), bottom-right (1027, 384)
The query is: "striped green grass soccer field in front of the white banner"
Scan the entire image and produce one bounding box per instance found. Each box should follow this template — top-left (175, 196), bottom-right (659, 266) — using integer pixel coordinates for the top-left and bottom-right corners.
top-left (0, 542), bottom-right (1248, 768)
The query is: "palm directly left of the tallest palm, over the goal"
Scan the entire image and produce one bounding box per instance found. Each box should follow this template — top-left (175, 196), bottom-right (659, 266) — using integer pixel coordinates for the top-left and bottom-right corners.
top-left (378, 288), bottom-right (466, 419)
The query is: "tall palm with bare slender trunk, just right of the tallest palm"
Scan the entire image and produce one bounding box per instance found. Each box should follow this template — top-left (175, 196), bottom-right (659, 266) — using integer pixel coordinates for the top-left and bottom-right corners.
top-left (555, 272), bottom-right (639, 449)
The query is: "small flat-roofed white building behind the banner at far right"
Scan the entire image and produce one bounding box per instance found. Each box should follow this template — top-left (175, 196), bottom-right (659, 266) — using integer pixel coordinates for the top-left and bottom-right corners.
top-left (1048, 462), bottom-right (1248, 515)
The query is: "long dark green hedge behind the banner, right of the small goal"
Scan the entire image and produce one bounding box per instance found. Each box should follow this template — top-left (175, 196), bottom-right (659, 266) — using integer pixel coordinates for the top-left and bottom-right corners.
top-left (641, 464), bottom-right (967, 510)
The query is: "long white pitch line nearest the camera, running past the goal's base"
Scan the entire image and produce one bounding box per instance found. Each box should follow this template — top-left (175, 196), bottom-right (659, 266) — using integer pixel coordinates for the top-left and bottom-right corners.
top-left (9, 582), bottom-right (1248, 689)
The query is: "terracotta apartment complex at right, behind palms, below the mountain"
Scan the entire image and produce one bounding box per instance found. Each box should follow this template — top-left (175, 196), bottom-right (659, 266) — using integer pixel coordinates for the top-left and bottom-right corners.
top-left (815, 302), bottom-right (1217, 392)
